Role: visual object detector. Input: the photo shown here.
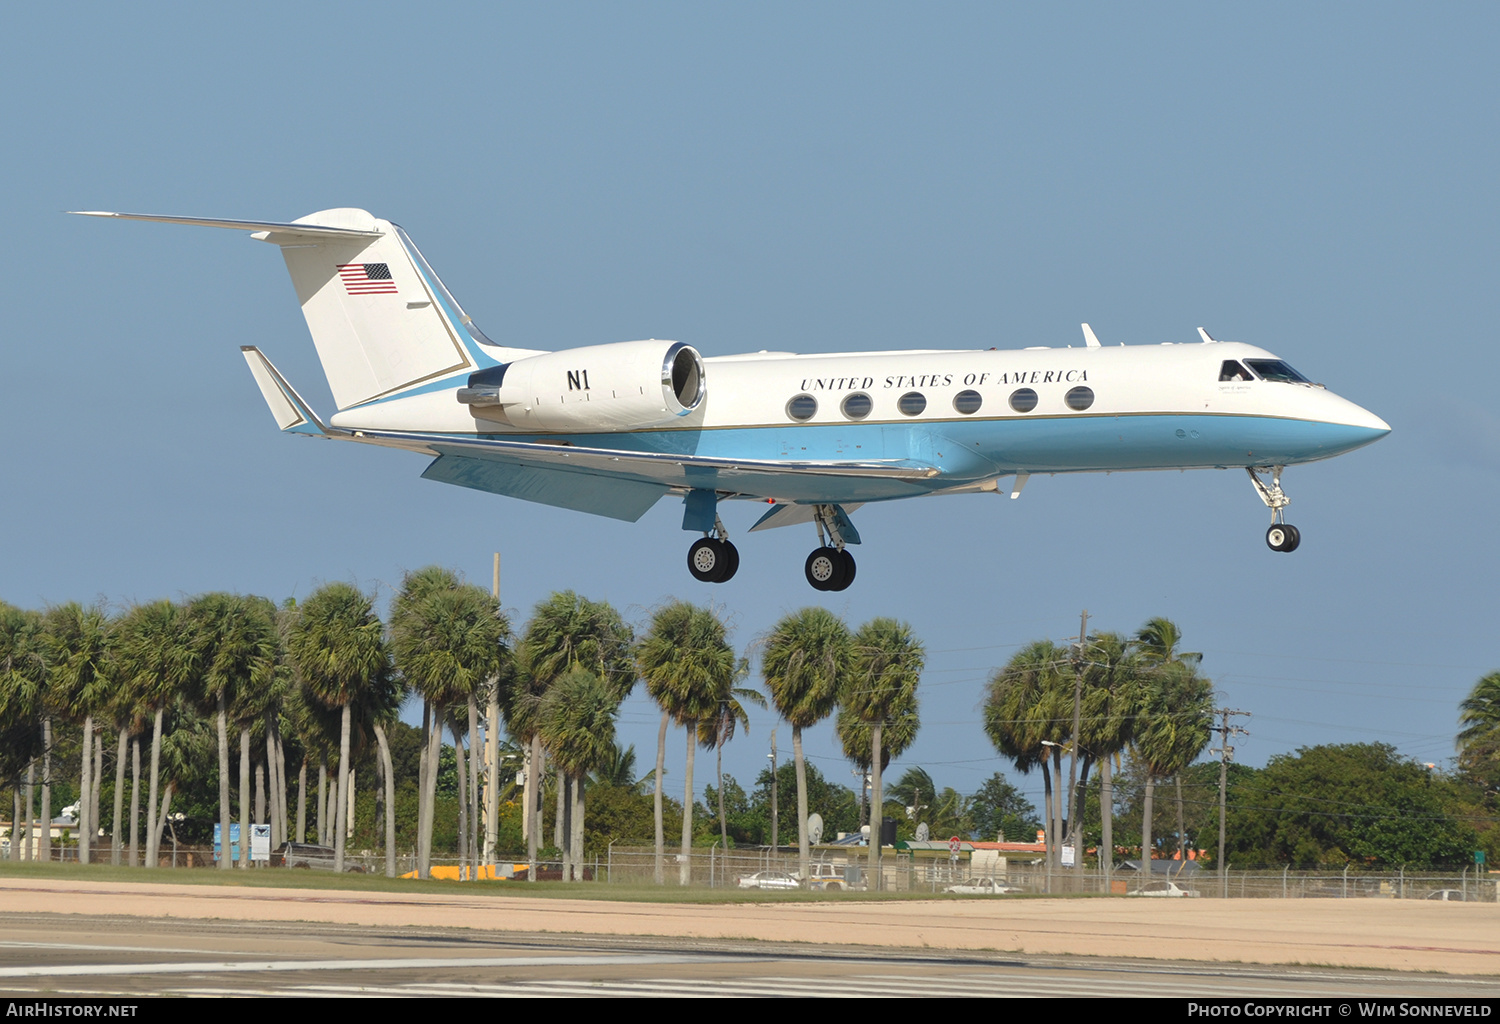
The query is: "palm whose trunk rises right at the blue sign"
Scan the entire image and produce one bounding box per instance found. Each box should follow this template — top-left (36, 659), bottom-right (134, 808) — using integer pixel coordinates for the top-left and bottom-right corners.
top-left (192, 594), bottom-right (278, 871)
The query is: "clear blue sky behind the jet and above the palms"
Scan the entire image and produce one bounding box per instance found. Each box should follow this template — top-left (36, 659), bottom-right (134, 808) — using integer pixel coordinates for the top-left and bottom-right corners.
top-left (0, 3), bottom-right (1500, 827)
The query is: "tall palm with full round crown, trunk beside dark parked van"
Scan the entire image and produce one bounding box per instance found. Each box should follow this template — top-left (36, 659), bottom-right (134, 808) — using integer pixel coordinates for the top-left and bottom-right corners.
top-left (288, 583), bottom-right (390, 871)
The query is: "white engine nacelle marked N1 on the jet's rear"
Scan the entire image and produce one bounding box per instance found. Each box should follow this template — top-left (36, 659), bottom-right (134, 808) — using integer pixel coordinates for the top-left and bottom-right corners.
top-left (459, 340), bottom-right (707, 432)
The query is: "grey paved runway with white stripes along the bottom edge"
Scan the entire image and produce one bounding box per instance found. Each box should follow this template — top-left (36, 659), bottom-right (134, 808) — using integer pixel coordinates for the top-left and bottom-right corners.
top-left (0, 913), bottom-right (1500, 1000)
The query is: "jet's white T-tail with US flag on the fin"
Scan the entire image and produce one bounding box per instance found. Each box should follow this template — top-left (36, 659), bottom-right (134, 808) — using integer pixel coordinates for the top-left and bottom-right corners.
top-left (76, 208), bottom-right (543, 411)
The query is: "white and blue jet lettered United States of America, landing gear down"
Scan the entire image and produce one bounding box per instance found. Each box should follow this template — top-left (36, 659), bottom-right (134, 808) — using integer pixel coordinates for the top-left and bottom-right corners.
top-left (86, 210), bottom-right (1391, 591)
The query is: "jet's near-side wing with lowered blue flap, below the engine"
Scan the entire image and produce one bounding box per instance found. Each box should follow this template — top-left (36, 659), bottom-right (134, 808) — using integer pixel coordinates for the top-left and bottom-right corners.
top-left (347, 430), bottom-right (939, 522)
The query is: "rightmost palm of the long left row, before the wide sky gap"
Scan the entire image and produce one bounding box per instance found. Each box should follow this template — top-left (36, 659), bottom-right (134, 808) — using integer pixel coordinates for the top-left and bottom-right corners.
top-left (839, 619), bottom-right (926, 889)
